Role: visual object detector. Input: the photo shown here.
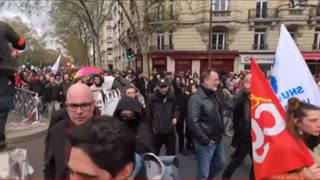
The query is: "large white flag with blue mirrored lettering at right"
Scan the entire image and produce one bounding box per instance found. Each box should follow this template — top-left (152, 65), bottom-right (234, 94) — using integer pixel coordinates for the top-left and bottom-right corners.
top-left (271, 24), bottom-right (320, 108)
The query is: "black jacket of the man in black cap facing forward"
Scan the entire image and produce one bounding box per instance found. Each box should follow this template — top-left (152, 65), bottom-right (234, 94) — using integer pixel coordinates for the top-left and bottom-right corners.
top-left (146, 90), bottom-right (179, 134)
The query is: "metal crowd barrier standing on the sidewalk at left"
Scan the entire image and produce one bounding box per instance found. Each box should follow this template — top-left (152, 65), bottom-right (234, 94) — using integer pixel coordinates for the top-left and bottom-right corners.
top-left (13, 88), bottom-right (41, 125)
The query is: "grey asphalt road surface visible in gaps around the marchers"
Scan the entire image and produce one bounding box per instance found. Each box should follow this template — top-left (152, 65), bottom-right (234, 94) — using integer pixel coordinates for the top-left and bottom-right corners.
top-left (13, 136), bottom-right (250, 179)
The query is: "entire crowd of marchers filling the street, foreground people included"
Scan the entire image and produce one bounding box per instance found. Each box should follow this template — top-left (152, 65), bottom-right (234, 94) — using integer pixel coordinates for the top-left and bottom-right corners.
top-left (0, 21), bottom-right (320, 179)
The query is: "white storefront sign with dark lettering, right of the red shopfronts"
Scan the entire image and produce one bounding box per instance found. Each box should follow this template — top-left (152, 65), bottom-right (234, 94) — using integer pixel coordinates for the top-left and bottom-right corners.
top-left (240, 54), bottom-right (275, 64)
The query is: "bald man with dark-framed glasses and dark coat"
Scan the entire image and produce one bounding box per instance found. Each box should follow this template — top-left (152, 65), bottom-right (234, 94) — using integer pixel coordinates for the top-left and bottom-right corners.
top-left (44, 83), bottom-right (95, 179)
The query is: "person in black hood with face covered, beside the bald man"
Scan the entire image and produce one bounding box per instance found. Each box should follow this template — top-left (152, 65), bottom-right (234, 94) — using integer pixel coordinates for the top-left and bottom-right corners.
top-left (114, 96), bottom-right (153, 155)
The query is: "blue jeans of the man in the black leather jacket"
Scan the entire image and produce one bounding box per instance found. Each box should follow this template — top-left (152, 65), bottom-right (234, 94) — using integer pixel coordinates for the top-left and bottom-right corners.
top-left (194, 141), bottom-right (226, 179)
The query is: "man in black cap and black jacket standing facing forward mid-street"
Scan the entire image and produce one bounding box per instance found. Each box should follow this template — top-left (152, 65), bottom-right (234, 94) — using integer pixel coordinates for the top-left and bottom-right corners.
top-left (146, 79), bottom-right (179, 155)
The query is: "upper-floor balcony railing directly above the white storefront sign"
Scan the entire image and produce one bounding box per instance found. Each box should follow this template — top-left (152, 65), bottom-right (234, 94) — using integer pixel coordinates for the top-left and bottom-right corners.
top-left (249, 8), bottom-right (278, 19)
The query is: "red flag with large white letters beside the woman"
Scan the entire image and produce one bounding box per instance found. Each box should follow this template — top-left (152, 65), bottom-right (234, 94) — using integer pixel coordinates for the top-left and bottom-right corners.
top-left (250, 58), bottom-right (314, 179)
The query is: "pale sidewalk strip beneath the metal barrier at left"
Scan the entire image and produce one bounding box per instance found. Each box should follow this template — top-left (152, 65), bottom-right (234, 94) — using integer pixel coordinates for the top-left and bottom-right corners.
top-left (6, 112), bottom-right (49, 144)
